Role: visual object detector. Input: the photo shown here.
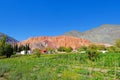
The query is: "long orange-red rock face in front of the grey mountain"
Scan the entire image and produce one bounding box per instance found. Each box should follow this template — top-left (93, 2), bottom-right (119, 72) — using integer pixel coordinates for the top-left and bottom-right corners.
top-left (19, 36), bottom-right (91, 49)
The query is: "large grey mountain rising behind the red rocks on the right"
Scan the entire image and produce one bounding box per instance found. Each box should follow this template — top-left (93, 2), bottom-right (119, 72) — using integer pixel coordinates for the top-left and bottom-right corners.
top-left (64, 24), bottom-right (120, 44)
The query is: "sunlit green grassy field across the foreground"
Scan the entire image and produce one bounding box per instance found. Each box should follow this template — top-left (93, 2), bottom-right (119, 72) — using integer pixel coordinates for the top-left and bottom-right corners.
top-left (0, 53), bottom-right (120, 80)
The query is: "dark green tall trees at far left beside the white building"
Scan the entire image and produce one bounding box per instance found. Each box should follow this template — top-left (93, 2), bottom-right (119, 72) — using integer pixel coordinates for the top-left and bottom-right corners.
top-left (0, 36), bottom-right (30, 58)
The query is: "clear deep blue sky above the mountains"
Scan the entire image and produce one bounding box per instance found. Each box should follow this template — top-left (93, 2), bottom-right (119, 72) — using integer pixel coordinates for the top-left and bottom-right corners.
top-left (0, 0), bottom-right (120, 41)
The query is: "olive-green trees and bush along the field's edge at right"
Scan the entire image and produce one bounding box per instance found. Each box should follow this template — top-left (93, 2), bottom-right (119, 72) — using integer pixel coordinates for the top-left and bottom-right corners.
top-left (78, 39), bottom-right (120, 61)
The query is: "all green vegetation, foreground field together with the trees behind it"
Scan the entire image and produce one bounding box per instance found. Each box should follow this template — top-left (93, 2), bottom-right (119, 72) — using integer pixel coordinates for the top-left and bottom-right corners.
top-left (0, 37), bottom-right (120, 80)
